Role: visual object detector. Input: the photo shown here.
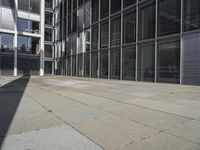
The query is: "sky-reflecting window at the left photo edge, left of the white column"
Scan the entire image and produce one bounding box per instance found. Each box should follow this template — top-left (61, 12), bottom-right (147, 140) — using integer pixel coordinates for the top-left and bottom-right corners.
top-left (0, 33), bottom-right (13, 52)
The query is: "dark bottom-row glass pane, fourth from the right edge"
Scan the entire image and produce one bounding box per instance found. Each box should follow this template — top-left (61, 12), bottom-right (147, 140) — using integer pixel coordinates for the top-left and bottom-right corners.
top-left (122, 46), bottom-right (136, 80)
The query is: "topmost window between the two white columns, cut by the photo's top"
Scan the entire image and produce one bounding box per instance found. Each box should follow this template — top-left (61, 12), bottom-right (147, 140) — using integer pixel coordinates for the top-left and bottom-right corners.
top-left (18, 0), bottom-right (41, 14)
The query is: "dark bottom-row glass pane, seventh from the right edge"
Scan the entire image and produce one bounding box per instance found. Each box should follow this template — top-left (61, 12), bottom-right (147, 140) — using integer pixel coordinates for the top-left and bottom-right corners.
top-left (91, 52), bottom-right (98, 78)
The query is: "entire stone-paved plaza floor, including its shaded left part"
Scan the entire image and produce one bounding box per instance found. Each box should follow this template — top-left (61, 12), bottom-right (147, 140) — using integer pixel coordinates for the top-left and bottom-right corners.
top-left (0, 76), bottom-right (200, 150)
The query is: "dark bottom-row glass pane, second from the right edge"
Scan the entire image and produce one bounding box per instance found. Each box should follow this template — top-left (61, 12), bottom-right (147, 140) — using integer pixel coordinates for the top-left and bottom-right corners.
top-left (158, 39), bottom-right (180, 83)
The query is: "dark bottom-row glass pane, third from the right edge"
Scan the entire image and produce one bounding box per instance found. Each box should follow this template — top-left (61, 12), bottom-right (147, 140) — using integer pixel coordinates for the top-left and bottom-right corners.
top-left (138, 44), bottom-right (155, 82)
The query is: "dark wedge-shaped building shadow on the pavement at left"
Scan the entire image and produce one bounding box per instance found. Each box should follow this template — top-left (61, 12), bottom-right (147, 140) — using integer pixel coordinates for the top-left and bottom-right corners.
top-left (0, 76), bottom-right (30, 149)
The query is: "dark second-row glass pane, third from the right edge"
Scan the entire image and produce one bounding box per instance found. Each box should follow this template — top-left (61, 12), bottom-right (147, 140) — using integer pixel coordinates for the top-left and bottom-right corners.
top-left (139, 2), bottom-right (156, 40)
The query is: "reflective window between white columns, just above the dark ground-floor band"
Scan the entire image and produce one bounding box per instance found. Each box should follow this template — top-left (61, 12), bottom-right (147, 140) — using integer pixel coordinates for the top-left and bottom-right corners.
top-left (17, 36), bottom-right (40, 54)
